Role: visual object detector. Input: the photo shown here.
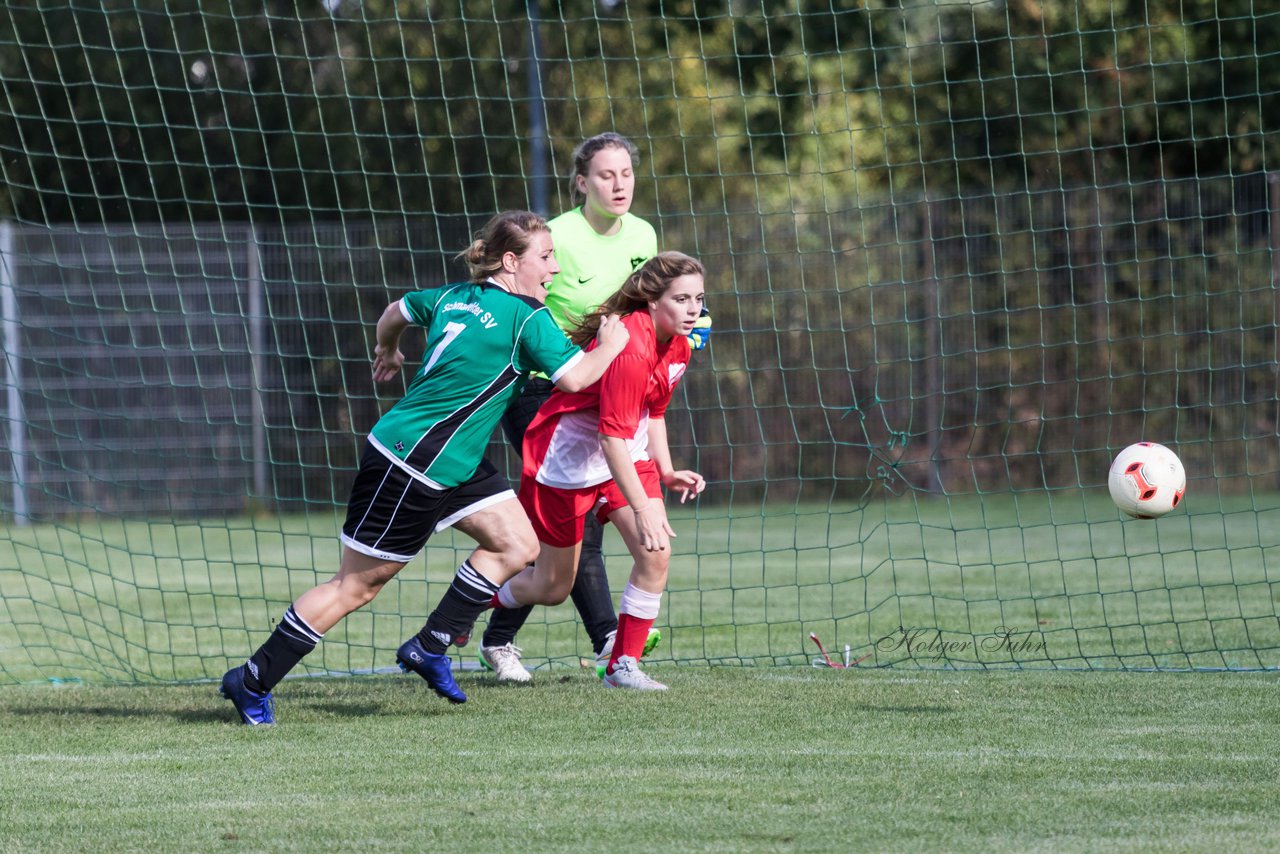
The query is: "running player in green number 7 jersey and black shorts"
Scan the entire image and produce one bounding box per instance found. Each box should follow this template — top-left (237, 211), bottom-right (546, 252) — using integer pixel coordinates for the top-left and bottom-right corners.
top-left (221, 211), bottom-right (628, 725)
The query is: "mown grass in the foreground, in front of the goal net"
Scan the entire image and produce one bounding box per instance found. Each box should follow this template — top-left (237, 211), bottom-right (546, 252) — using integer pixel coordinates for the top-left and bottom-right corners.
top-left (0, 665), bottom-right (1280, 851)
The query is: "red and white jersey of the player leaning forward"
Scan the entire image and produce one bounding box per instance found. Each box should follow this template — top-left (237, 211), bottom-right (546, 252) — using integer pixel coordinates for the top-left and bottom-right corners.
top-left (521, 311), bottom-right (690, 489)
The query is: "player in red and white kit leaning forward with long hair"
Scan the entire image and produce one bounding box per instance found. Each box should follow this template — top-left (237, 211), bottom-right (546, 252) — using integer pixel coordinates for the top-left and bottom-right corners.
top-left (497, 252), bottom-right (707, 690)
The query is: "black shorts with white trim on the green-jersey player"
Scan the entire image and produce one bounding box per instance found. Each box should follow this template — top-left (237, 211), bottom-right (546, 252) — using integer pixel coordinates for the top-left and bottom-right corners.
top-left (342, 442), bottom-right (516, 563)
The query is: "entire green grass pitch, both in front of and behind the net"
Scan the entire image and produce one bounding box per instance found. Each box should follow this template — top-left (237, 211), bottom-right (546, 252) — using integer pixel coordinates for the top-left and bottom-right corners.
top-left (0, 493), bottom-right (1280, 851)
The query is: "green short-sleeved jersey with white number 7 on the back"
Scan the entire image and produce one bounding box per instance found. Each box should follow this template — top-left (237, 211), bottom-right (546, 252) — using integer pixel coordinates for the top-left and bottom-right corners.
top-left (369, 282), bottom-right (582, 489)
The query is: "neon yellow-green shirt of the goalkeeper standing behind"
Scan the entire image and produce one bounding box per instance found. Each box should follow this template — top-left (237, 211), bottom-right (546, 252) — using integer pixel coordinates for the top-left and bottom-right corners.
top-left (547, 207), bottom-right (658, 329)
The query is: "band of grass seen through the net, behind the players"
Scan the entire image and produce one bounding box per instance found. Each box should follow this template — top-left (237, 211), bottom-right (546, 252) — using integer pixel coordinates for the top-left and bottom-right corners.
top-left (0, 492), bottom-right (1280, 682)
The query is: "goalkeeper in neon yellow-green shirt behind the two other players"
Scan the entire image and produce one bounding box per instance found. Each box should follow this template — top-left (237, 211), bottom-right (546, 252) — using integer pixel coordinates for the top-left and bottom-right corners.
top-left (480, 132), bottom-right (712, 682)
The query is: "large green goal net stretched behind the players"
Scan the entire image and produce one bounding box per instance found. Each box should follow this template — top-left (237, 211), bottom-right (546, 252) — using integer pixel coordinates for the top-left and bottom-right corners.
top-left (0, 0), bottom-right (1280, 682)
